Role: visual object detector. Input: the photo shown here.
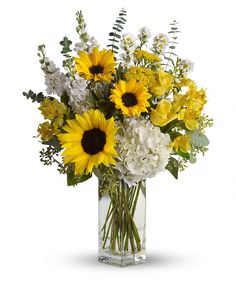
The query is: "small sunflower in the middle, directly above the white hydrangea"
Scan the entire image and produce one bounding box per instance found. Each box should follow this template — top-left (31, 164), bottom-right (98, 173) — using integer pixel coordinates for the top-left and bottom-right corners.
top-left (110, 78), bottom-right (151, 116)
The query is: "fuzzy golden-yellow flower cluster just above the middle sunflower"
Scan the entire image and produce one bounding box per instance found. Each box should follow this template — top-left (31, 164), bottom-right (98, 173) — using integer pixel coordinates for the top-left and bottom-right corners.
top-left (125, 66), bottom-right (155, 87)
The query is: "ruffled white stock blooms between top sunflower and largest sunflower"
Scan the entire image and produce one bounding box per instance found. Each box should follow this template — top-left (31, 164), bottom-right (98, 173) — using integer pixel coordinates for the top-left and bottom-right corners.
top-left (65, 75), bottom-right (90, 114)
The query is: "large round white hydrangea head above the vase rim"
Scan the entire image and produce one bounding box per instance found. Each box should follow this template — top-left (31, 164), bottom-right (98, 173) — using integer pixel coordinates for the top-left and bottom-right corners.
top-left (116, 118), bottom-right (171, 189)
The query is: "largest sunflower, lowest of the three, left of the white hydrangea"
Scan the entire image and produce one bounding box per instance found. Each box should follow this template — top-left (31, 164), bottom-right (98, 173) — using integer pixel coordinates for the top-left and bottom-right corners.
top-left (58, 110), bottom-right (117, 175)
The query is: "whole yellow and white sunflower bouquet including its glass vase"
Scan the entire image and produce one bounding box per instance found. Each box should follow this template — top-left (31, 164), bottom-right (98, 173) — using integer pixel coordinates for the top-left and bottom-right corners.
top-left (23, 9), bottom-right (212, 266)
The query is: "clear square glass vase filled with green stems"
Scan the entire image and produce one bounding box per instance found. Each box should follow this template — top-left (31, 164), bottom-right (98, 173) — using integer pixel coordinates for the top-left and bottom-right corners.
top-left (98, 176), bottom-right (146, 266)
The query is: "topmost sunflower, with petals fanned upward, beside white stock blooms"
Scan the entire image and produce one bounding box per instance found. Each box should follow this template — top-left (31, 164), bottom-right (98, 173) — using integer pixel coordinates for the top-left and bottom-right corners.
top-left (74, 47), bottom-right (116, 82)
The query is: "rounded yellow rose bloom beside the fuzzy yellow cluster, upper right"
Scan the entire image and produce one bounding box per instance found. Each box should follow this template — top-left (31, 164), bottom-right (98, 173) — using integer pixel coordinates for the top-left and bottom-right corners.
top-left (150, 70), bottom-right (172, 96)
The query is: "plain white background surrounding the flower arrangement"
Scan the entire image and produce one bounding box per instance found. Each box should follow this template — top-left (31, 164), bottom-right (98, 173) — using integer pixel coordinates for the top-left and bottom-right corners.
top-left (0, 0), bottom-right (236, 283)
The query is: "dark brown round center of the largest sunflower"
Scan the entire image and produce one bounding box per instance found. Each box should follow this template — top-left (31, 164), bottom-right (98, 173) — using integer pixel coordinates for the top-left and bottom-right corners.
top-left (81, 128), bottom-right (106, 155)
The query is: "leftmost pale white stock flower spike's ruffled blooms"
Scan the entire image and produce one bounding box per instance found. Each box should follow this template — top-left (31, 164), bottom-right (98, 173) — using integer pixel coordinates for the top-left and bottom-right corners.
top-left (45, 58), bottom-right (66, 96)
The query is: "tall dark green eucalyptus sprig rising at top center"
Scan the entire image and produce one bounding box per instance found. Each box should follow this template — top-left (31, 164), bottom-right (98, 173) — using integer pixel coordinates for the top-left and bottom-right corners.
top-left (107, 8), bottom-right (127, 53)
